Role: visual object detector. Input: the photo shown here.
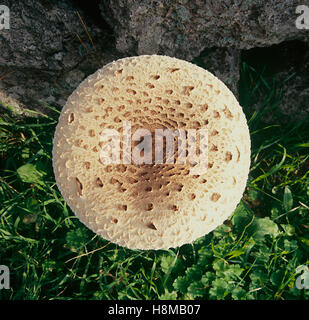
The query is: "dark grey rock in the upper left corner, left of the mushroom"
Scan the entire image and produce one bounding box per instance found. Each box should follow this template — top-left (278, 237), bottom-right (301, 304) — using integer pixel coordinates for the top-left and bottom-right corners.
top-left (0, 0), bottom-right (120, 113)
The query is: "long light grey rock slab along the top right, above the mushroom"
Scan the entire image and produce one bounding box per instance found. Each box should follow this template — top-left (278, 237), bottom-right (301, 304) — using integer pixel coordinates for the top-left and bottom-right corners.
top-left (100, 0), bottom-right (309, 60)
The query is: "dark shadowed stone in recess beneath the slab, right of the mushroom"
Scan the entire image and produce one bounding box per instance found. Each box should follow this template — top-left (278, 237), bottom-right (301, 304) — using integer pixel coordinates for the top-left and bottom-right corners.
top-left (243, 41), bottom-right (309, 124)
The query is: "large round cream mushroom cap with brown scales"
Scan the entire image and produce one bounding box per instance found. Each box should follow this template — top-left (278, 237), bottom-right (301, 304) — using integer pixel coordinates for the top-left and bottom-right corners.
top-left (53, 55), bottom-right (250, 250)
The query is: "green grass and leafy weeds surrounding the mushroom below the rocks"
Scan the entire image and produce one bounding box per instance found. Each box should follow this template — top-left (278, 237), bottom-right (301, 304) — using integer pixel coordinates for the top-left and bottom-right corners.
top-left (0, 63), bottom-right (309, 300)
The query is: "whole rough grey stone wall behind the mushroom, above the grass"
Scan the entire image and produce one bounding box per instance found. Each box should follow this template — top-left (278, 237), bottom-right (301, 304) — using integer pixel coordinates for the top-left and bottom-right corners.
top-left (0, 0), bottom-right (309, 120)
